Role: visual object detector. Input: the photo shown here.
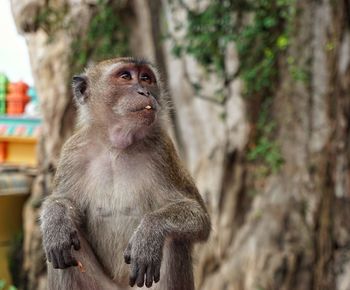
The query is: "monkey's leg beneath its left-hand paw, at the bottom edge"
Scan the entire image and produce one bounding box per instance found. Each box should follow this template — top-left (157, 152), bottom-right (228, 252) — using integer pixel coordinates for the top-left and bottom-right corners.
top-left (47, 233), bottom-right (123, 290)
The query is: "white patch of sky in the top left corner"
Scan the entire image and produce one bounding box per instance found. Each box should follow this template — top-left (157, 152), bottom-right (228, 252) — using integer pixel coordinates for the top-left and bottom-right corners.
top-left (0, 0), bottom-right (34, 85)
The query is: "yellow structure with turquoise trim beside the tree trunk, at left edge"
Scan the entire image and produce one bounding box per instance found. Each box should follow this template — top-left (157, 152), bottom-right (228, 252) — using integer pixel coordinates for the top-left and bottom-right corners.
top-left (0, 115), bottom-right (41, 284)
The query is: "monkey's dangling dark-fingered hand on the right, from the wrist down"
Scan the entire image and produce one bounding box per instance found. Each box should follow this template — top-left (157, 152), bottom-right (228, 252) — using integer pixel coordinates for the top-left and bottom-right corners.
top-left (124, 219), bottom-right (164, 287)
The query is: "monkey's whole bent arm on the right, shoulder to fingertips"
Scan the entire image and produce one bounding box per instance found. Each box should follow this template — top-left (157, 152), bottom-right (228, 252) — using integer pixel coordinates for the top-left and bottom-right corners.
top-left (124, 134), bottom-right (211, 287)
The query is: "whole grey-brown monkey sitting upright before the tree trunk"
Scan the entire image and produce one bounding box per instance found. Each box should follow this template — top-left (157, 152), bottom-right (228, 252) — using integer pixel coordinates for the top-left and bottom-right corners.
top-left (40, 57), bottom-right (211, 290)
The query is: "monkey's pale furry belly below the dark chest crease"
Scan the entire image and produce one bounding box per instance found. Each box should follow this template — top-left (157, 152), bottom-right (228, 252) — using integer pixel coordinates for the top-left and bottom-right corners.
top-left (87, 209), bottom-right (141, 287)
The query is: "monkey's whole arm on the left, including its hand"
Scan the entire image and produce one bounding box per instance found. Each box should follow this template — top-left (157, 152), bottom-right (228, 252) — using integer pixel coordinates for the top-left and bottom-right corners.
top-left (40, 137), bottom-right (87, 269)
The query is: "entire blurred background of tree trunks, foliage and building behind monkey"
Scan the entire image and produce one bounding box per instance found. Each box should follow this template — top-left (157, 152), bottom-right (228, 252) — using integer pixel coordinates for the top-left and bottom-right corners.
top-left (0, 0), bottom-right (350, 290)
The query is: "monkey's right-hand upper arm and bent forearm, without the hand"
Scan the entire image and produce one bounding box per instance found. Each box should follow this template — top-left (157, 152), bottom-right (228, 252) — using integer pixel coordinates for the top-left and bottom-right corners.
top-left (150, 134), bottom-right (211, 242)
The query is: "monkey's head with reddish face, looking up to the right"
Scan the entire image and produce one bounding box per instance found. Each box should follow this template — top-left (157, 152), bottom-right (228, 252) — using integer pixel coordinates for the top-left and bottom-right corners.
top-left (73, 58), bottom-right (165, 149)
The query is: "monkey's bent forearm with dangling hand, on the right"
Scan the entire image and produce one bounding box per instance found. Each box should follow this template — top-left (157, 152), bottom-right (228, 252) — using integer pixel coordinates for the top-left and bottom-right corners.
top-left (124, 198), bottom-right (211, 287)
